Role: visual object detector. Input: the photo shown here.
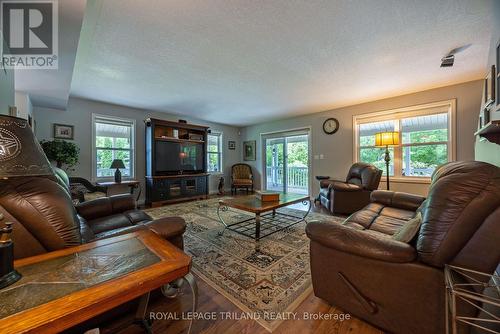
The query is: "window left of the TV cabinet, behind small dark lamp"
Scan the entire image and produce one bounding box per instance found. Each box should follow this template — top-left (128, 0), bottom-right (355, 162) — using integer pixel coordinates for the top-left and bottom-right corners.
top-left (92, 115), bottom-right (135, 179)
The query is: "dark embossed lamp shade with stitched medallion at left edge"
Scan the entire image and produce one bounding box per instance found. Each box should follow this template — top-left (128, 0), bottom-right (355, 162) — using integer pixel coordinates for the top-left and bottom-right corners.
top-left (0, 115), bottom-right (54, 179)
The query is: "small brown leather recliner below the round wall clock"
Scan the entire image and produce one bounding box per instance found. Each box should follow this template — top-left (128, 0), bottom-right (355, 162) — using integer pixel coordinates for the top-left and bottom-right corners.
top-left (319, 162), bottom-right (382, 214)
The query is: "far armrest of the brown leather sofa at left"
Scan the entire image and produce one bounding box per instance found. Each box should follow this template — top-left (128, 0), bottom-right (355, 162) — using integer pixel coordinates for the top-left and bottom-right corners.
top-left (75, 194), bottom-right (136, 220)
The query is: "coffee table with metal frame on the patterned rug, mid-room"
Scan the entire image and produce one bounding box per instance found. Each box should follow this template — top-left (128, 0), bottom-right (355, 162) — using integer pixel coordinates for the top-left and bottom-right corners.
top-left (217, 193), bottom-right (311, 241)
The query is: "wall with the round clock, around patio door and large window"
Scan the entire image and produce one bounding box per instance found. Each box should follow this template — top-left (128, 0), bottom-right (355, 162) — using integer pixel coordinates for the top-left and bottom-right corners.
top-left (242, 80), bottom-right (482, 195)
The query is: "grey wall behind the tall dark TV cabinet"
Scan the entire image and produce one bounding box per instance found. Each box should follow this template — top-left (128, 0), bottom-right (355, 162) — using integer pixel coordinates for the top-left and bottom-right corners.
top-left (34, 97), bottom-right (241, 198)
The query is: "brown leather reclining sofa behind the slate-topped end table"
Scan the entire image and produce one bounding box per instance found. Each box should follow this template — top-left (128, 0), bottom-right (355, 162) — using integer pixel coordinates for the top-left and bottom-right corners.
top-left (0, 170), bottom-right (186, 259)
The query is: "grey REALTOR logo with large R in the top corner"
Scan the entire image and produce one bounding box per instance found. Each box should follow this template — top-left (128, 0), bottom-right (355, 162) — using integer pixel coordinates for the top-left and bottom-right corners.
top-left (1, 0), bottom-right (58, 69)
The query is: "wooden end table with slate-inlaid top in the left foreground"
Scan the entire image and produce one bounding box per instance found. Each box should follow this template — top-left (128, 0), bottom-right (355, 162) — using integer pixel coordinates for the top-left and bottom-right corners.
top-left (0, 230), bottom-right (197, 333)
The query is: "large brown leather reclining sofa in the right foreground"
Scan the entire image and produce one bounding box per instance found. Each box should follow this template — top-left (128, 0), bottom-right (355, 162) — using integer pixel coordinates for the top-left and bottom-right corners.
top-left (306, 162), bottom-right (500, 333)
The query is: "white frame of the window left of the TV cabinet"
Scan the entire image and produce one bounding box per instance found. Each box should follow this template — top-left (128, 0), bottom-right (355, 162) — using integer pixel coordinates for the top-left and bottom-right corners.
top-left (91, 113), bottom-right (136, 181)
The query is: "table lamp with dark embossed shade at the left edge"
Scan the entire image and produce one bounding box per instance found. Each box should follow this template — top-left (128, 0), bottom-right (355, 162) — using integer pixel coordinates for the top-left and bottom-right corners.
top-left (0, 115), bottom-right (54, 289)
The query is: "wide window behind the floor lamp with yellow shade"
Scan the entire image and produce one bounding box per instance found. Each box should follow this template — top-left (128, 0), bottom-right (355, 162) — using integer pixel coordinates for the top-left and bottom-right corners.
top-left (354, 100), bottom-right (455, 179)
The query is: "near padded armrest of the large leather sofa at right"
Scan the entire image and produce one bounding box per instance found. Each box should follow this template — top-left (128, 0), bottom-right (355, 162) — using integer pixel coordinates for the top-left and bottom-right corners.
top-left (306, 222), bottom-right (417, 263)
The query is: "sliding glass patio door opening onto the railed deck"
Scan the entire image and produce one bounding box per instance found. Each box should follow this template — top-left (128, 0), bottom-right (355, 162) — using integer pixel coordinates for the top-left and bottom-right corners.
top-left (264, 130), bottom-right (309, 195)
